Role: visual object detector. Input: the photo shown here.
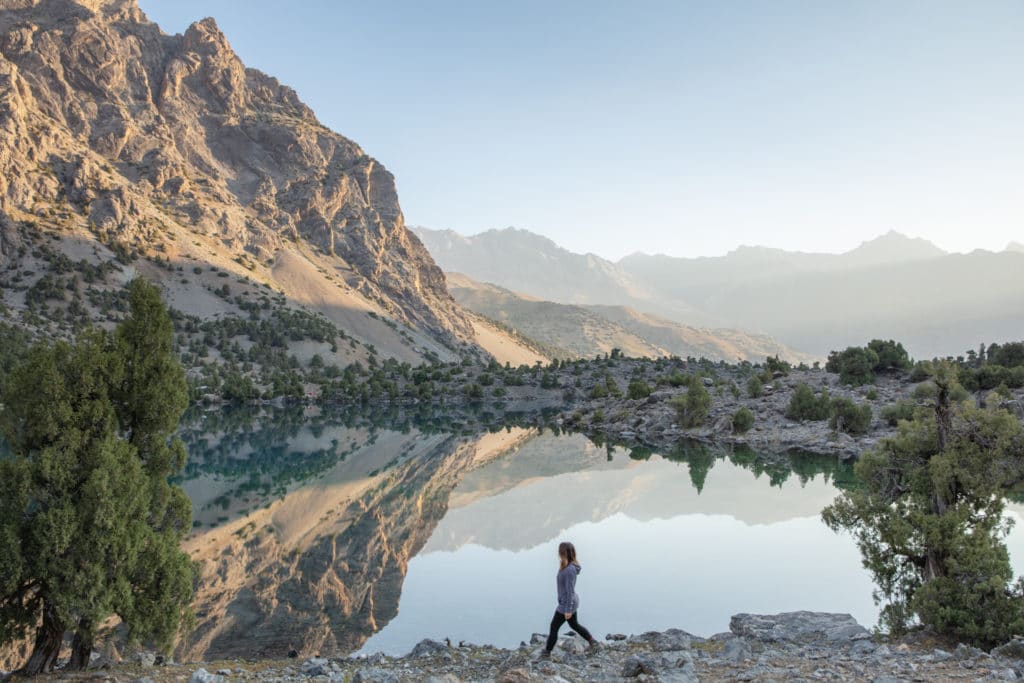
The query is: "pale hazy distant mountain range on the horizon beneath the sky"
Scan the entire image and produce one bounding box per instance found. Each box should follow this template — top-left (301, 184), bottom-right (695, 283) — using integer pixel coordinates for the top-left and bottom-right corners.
top-left (413, 227), bottom-right (1024, 357)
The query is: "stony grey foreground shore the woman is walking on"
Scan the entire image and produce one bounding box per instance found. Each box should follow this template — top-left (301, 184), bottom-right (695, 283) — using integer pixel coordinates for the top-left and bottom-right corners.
top-left (14, 612), bottom-right (1024, 683)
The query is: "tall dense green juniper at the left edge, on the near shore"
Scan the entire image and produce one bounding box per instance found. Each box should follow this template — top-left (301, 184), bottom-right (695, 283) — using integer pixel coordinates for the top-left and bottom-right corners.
top-left (0, 281), bottom-right (193, 674)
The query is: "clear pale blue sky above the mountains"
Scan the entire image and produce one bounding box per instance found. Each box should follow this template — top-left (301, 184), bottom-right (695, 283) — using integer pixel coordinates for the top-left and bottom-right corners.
top-left (140, 0), bottom-right (1024, 258)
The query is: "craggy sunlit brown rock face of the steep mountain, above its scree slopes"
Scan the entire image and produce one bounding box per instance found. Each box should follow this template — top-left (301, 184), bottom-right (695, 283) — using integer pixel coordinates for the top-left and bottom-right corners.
top-left (0, 0), bottom-right (472, 343)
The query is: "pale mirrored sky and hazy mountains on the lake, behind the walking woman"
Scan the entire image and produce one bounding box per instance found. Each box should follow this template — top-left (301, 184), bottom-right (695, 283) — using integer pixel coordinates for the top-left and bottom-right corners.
top-left (364, 435), bottom-right (878, 653)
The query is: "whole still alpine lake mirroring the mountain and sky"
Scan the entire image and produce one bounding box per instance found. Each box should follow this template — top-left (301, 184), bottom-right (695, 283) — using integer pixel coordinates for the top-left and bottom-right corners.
top-left (177, 405), bottom-right (1024, 659)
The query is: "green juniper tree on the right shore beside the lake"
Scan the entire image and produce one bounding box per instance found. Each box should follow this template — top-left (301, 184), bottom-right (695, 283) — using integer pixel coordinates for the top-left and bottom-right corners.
top-left (822, 364), bottom-right (1024, 646)
